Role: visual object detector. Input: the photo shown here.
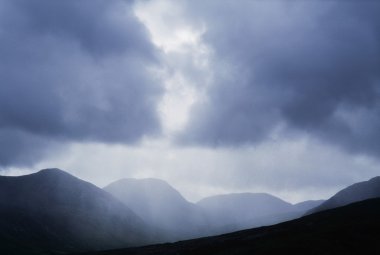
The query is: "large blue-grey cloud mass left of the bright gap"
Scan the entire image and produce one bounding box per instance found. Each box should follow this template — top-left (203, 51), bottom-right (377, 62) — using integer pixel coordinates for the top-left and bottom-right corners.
top-left (0, 0), bottom-right (161, 166)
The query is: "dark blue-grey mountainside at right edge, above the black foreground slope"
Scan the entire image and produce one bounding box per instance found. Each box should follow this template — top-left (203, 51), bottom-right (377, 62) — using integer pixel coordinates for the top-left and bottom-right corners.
top-left (307, 176), bottom-right (380, 214)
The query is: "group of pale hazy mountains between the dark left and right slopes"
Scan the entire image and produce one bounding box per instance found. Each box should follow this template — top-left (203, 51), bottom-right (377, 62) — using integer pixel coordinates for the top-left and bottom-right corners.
top-left (104, 178), bottom-right (322, 238)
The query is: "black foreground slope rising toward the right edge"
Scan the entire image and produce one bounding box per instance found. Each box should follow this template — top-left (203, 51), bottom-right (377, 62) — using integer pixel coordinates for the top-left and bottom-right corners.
top-left (80, 198), bottom-right (380, 255)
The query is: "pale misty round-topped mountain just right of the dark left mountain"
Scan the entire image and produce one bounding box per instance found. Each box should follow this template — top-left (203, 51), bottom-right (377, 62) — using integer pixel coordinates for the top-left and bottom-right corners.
top-left (104, 178), bottom-right (210, 240)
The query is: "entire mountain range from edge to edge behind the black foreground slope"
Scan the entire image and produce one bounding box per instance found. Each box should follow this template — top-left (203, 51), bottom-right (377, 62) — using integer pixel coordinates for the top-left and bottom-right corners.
top-left (0, 169), bottom-right (380, 254)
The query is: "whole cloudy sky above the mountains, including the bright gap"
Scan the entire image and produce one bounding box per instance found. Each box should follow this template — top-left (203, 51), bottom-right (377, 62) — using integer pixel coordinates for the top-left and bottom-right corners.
top-left (0, 0), bottom-right (380, 202)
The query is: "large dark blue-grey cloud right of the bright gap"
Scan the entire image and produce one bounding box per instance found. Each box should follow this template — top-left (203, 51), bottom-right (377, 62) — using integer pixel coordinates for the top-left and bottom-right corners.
top-left (184, 1), bottom-right (380, 155)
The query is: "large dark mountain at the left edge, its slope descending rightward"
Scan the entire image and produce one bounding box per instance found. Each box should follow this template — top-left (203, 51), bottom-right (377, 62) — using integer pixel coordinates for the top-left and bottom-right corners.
top-left (0, 169), bottom-right (161, 254)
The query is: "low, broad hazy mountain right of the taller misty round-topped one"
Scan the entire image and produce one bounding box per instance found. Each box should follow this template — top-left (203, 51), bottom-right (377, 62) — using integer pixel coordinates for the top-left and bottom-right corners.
top-left (197, 193), bottom-right (299, 233)
